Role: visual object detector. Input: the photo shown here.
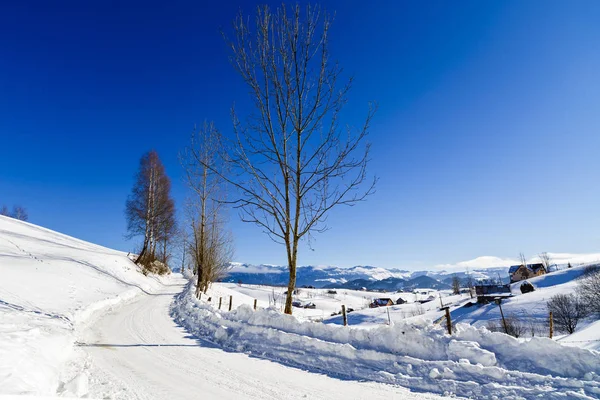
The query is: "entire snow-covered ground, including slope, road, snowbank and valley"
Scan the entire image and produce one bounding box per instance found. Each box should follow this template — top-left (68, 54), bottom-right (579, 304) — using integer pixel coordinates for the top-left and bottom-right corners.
top-left (0, 217), bottom-right (600, 399)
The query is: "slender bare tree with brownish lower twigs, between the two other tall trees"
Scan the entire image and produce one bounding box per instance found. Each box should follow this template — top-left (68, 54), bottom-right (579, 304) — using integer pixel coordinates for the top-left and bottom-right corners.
top-left (180, 123), bottom-right (233, 296)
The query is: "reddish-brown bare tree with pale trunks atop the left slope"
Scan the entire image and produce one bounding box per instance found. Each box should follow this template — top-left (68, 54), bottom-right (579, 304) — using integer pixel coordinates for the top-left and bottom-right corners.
top-left (125, 151), bottom-right (175, 266)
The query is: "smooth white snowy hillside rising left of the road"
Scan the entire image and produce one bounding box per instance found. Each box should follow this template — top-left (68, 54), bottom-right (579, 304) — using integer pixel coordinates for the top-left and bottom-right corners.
top-left (0, 216), bottom-right (165, 395)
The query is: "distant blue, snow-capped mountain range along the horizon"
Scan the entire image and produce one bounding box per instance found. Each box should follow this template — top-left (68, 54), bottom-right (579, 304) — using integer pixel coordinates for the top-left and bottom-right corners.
top-left (224, 263), bottom-right (508, 291)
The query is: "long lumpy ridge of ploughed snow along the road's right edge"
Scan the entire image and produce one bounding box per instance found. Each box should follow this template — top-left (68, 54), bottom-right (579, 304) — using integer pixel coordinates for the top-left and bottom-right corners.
top-left (171, 284), bottom-right (600, 399)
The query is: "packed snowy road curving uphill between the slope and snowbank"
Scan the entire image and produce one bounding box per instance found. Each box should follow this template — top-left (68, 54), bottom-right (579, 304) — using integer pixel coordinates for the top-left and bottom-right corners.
top-left (80, 278), bottom-right (440, 399)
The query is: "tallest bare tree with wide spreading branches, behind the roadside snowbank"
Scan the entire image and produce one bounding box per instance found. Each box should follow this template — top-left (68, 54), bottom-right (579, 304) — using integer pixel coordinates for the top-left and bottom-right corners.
top-left (221, 5), bottom-right (376, 314)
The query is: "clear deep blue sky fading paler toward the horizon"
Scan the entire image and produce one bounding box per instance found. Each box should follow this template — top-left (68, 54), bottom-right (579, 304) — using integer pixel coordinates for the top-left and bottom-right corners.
top-left (0, 0), bottom-right (600, 268)
